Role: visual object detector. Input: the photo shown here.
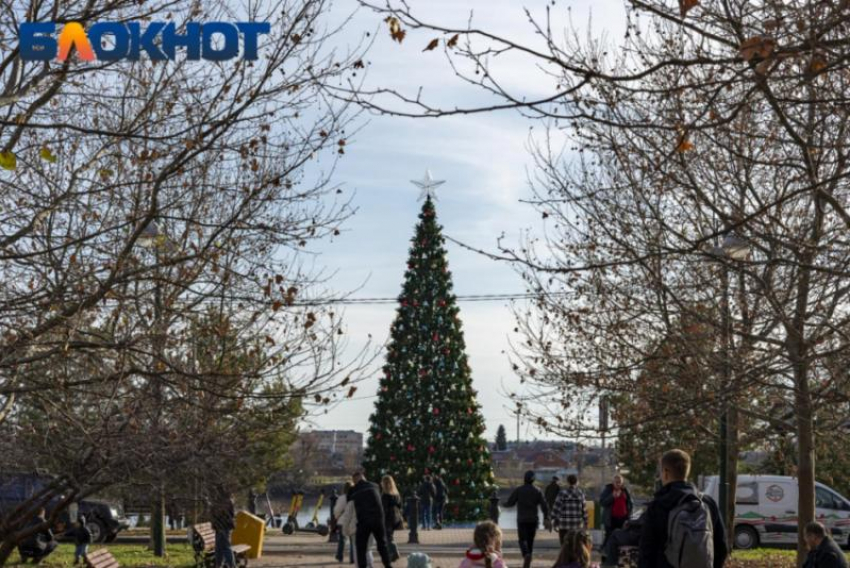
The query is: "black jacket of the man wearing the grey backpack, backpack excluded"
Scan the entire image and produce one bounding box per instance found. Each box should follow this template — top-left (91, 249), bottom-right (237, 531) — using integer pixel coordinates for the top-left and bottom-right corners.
top-left (638, 481), bottom-right (728, 568)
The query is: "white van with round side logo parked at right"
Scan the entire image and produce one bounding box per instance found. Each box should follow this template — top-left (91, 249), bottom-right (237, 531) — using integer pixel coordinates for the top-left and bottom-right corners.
top-left (703, 475), bottom-right (850, 549)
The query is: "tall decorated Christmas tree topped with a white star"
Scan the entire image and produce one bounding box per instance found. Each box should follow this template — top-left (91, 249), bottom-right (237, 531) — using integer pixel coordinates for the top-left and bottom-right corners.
top-left (365, 173), bottom-right (493, 520)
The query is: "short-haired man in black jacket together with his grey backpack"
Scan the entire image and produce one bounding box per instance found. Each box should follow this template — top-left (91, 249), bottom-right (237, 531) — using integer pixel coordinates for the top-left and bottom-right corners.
top-left (638, 450), bottom-right (728, 568)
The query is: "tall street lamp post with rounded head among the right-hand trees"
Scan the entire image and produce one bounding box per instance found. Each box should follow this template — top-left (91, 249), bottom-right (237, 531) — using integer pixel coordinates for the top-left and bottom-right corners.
top-left (709, 233), bottom-right (750, 538)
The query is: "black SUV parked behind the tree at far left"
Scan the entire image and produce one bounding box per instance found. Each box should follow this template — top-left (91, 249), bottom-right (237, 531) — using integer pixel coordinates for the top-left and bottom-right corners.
top-left (0, 473), bottom-right (130, 542)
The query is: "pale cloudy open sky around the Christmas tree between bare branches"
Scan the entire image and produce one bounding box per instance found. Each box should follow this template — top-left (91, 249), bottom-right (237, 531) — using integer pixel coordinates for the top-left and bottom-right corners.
top-left (309, 0), bottom-right (625, 439)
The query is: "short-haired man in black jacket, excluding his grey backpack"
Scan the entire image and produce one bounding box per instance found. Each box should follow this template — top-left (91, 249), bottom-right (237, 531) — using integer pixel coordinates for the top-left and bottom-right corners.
top-left (638, 450), bottom-right (728, 568)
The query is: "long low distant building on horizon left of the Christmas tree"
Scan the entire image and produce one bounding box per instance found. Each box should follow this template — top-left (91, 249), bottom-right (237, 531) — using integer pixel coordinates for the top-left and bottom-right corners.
top-left (290, 430), bottom-right (363, 475)
